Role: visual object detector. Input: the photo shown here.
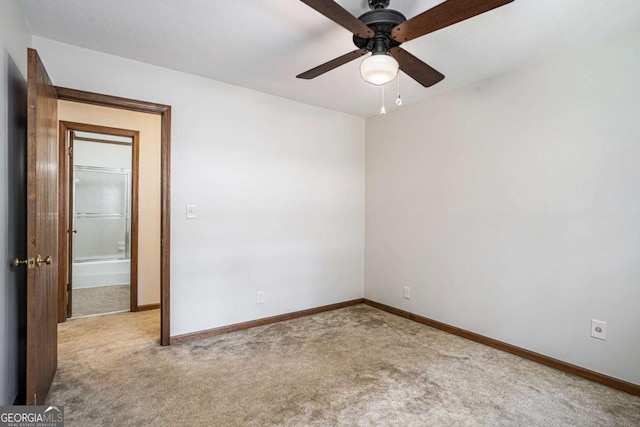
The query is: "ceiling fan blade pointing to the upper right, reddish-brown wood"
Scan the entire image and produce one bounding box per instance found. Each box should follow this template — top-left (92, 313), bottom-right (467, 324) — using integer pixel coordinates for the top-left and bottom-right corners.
top-left (391, 0), bottom-right (513, 43)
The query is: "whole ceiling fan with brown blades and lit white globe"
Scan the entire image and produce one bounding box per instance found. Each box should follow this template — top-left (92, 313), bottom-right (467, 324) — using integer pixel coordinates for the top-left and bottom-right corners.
top-left (296, 0), bottom-right (513, 87)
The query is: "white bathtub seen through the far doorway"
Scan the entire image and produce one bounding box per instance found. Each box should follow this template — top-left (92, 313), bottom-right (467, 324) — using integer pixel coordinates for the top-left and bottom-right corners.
top-left (72, 259), bottom-right (131, 289)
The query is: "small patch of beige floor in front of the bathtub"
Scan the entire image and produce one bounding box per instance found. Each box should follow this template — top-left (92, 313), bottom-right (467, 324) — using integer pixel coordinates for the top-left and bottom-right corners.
top-left (71, 285), bottom-right (131, 317)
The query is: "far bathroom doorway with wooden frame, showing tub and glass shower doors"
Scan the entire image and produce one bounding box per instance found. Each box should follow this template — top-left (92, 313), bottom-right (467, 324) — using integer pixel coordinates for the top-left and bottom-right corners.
top-left (60, 121), bottom-right (140, 318)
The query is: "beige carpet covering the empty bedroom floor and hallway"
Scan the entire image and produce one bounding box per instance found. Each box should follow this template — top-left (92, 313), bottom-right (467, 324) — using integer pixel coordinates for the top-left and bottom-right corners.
top-left (48, 305), bottom-right (640, 427)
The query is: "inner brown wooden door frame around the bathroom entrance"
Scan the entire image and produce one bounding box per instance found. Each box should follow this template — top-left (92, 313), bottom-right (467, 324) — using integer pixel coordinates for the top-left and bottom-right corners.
top-left (58, 120), bottom-right (140, 322)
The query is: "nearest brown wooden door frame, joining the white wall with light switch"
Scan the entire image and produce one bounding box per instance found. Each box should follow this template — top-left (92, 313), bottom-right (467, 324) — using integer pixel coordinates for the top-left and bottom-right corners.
top-left (55, 86), bottom-right (171, 345)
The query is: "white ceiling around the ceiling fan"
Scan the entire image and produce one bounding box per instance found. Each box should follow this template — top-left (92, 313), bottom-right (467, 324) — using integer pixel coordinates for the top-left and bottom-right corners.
top-left (20, 0), bottom-right (640, 117)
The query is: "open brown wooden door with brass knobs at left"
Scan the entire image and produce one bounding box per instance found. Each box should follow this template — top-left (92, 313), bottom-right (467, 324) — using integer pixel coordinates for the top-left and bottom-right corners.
top-left (26, 49), bottom-right (58, 405)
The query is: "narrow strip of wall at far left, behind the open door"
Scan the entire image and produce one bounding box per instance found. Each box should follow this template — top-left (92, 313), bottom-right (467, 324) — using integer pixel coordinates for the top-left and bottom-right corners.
top-left (0, 0), bottom-right (31, 405)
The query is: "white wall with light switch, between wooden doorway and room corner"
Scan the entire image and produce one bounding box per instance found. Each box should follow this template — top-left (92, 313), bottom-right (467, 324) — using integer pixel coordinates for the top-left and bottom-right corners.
top-left (33, 37), bottom-right (364, 335)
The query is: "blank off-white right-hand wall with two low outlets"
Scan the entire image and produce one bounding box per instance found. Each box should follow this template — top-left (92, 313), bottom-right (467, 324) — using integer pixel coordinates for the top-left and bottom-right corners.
top-left (365, 28), bottom-right (640, 384)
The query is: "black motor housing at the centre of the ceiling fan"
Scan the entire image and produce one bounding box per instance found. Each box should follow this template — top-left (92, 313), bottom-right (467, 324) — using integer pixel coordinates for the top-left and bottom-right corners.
top-left (353, 8), bottom-right (407, 54)
